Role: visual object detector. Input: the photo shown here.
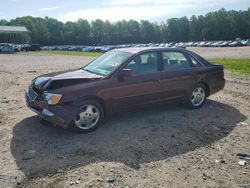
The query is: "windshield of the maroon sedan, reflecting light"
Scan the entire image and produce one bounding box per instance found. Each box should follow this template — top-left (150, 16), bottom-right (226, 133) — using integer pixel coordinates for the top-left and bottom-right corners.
top-left (83, 51), bottom-right (131, 75)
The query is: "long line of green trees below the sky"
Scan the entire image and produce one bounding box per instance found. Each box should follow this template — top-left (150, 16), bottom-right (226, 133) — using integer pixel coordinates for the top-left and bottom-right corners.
top-left (0, 7), bottom-right (250, 45)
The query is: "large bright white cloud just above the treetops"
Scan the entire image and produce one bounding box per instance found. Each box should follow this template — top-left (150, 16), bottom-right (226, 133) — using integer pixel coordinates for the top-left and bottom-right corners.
top-left (57, 0), bottom-right (249, 22)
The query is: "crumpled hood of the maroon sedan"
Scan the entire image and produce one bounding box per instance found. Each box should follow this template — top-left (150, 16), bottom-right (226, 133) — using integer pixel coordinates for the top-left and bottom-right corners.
top-left (32, 69), bottom-right (103, 90)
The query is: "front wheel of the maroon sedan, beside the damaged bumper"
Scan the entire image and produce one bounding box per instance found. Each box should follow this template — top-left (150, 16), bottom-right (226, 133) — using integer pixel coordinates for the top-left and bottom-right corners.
top-left (69, 100), bottom-right (104, 133)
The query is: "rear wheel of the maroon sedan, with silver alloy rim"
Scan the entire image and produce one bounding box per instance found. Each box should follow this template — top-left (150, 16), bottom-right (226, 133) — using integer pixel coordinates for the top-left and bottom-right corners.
top-left (187, 84), bottom-right (208, 109)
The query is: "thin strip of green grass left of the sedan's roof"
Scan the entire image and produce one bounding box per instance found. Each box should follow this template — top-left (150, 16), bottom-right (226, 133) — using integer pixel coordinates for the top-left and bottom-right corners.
top-left (40, 50), bottom-right (102, 57)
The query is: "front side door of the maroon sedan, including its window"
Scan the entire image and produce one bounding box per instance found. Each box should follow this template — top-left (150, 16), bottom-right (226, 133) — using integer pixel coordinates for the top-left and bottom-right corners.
top-left (101, 52), bottom-right (162, 111)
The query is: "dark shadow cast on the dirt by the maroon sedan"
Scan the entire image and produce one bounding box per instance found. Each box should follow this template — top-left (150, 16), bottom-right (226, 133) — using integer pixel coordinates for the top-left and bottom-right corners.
top-left (11, 100), bottom-right (246, 178)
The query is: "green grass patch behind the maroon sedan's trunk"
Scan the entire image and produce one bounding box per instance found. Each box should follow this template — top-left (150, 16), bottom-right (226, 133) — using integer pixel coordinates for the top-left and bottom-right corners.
top-left (209, 59), bottom-right (250, 76)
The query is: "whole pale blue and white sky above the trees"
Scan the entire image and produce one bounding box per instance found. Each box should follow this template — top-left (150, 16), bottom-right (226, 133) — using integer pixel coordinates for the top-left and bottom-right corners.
top-left (0, 0), bottom-right (250, 22)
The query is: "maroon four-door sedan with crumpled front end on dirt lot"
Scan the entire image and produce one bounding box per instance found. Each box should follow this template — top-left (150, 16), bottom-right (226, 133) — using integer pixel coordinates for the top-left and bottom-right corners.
top-left (26, 48), bottom-right (225, 132)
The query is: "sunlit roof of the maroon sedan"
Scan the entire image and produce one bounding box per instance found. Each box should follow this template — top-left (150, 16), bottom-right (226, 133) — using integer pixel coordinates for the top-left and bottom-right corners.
top-left (114, 47), bottom-right (184, 54)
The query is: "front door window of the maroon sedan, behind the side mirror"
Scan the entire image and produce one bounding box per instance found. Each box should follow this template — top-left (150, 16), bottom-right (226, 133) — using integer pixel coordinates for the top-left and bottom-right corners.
top-left (126, 53), bottom-right (158, 75)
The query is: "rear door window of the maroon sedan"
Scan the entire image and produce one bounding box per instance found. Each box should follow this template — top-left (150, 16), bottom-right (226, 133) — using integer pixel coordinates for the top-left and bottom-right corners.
top-left (162, 52), bottom-right (190, 71)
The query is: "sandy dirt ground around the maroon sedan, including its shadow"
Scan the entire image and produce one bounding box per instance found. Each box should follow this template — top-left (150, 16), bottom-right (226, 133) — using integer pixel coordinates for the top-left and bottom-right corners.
top-left (0, 48), bottom-right (250, 188)
